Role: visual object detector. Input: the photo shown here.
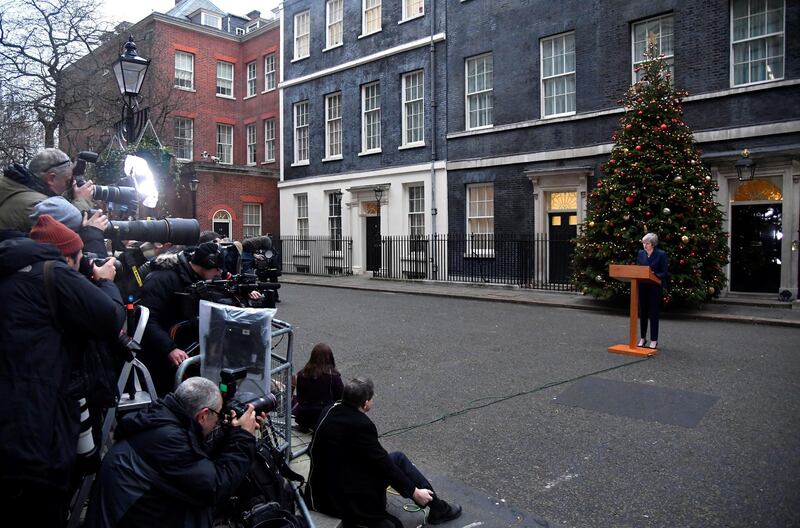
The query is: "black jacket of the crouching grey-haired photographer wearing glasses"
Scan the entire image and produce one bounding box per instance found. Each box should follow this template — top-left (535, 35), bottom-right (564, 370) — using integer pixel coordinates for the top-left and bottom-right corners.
top-left (86, 394), bottom-right (256, 528)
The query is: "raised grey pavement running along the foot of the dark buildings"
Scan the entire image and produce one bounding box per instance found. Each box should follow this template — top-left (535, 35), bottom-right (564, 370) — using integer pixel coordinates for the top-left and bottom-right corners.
top-left (281, 274), bottom-right (800, 327)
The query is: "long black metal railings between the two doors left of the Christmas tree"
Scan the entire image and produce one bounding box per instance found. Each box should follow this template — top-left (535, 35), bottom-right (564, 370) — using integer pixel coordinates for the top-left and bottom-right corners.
top-left (373, 233), bottom-right (574, 291)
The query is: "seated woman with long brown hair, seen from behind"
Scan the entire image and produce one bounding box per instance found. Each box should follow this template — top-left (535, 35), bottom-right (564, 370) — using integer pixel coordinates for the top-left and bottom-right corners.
top-left (292, 343), bottom-right (344, 429)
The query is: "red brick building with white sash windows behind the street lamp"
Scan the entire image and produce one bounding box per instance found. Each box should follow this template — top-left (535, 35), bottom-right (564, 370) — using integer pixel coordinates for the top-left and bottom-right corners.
top-left (65, 0), bottom-right (280, 239)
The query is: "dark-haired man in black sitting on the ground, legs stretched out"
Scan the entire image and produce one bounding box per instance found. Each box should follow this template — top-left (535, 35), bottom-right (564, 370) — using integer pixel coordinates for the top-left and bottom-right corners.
top-left (306, 378), bottom-right (461, 528)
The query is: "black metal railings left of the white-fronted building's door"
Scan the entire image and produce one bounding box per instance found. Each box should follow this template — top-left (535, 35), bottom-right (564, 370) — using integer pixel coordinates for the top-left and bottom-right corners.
top-left (272, 236), bottom-right (353, 275)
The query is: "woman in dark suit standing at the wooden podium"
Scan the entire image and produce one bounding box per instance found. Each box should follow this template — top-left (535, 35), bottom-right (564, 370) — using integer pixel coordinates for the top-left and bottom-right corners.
top-left (636, 233), bottom-right (668, 349)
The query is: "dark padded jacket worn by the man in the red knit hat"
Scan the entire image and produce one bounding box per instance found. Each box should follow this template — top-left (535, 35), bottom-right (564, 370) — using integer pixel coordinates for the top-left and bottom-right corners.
top-left (0, 238), bottom-right (125, 490)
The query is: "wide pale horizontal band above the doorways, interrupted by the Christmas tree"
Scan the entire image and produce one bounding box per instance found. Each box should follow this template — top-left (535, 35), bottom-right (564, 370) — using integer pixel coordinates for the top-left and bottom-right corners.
top-left (447, 120), bottom-right (800, 170)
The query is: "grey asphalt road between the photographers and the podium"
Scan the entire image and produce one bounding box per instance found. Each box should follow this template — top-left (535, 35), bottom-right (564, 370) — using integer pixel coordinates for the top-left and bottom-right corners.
top-left (277, 285), bottom-right (800, 527)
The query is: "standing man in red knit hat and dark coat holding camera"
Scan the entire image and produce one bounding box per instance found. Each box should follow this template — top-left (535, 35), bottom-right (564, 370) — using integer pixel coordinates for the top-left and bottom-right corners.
top-left (0, 215), bottom-right (125, 526)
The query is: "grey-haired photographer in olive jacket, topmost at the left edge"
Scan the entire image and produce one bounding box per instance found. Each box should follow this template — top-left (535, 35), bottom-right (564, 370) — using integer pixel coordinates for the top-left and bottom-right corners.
top-left (0, 148), bottom-right (94, 233)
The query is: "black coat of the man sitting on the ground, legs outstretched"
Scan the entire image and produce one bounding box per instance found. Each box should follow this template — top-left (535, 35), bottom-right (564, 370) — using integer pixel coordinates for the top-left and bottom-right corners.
top-left (306, 402), bottom-right (414, 524)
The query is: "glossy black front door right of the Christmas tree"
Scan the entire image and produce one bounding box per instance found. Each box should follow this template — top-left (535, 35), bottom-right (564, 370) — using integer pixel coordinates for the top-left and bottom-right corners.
top-left (731, 203), bottom-right (783, 293)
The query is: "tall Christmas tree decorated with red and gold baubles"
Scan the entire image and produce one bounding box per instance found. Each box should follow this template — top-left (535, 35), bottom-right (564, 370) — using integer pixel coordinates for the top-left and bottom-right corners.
top-left (572, 44), bottom-right (728, 305)
